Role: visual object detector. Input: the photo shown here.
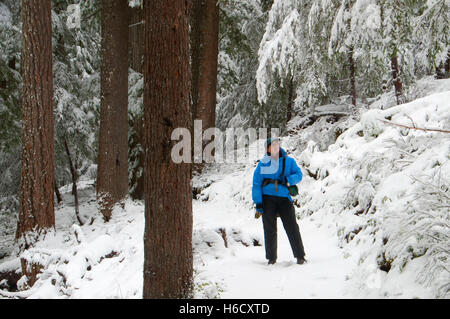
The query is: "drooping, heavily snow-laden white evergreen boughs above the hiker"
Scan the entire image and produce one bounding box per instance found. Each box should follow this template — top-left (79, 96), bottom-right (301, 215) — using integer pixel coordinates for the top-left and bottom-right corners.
top-left (257, 0), bottom-right (333, 123)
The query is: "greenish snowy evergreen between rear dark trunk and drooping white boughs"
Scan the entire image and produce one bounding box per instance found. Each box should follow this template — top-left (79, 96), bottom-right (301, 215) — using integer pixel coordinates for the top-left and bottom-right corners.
top-left (216, 0), bottom-right (270, 130)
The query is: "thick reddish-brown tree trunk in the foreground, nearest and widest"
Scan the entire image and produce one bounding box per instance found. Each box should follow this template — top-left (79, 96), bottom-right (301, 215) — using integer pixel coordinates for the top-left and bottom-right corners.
top-left (143, 0), bottom-right (193, 298)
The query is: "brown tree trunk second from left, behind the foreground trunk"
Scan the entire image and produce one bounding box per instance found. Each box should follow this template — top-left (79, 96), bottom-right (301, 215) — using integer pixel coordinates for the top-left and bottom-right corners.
top-left (97, 0), bottom-right (129, 221)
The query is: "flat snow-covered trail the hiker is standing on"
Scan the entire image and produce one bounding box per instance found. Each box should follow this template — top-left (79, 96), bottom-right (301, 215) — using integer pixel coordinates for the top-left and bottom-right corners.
top-left (194, 201), bottom-right (351, 299)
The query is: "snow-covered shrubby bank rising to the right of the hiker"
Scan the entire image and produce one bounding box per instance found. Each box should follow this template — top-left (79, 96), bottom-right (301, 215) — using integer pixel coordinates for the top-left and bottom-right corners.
top-left (299, 87), bottom-right (450, 298)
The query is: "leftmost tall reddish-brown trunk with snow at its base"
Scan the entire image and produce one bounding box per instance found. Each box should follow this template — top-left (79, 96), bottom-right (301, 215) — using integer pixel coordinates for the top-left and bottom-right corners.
top-left (16, 0), bottom-right (55, 249)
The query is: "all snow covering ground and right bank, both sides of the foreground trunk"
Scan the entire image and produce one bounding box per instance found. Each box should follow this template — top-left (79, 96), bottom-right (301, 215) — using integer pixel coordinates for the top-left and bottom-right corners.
top-left (0, 80), bottom-right (450, 298)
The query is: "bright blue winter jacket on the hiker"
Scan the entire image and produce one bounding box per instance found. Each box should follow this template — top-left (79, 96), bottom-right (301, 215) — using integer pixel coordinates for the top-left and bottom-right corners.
top-left (252, 147), bottom-right (303, 205)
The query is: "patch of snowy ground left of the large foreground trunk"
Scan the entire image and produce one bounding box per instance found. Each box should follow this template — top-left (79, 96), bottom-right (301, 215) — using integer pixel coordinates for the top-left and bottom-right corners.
top-left (0, 181), bottom-right (144, 298)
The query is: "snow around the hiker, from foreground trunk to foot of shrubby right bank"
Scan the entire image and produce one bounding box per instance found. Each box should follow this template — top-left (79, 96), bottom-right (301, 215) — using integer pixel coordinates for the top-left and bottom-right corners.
top-left (193, 140), bottom-right (358, 299)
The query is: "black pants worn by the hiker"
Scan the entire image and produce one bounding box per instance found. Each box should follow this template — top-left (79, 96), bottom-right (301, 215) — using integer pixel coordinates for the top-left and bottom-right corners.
top-left (262, 195), bottom-right (305, 260)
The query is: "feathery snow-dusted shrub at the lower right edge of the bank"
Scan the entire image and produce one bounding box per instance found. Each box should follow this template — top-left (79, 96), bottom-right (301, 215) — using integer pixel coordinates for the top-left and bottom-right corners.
top-left (386, 171), bottom-right (450, 297)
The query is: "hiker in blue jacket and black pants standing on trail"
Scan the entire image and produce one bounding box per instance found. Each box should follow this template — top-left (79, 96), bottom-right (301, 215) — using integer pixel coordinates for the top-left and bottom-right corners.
top-left (252, 138), bottom-right (306, 265)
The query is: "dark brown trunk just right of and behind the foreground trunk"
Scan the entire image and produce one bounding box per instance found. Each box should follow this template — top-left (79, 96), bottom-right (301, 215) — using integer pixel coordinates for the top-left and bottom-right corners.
top-left (190, 0), bottom-right (219, 165)
